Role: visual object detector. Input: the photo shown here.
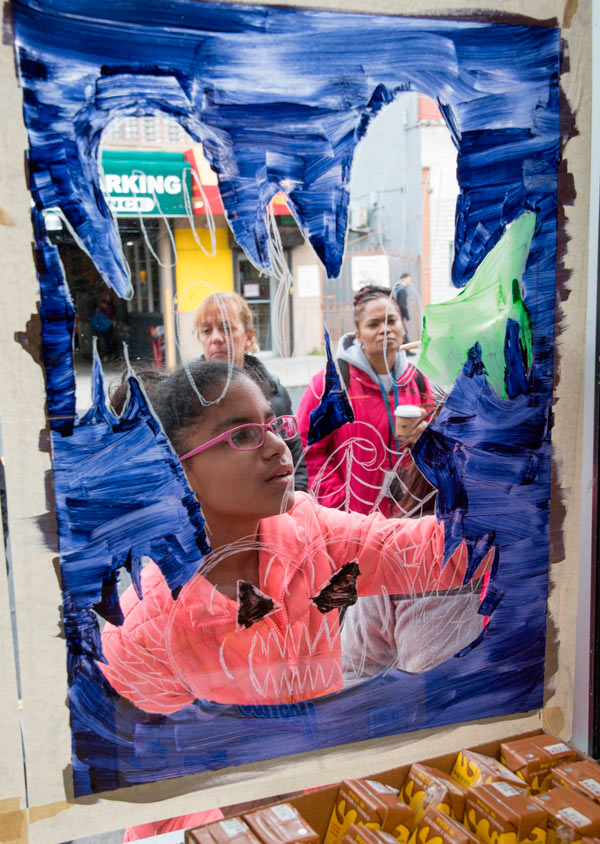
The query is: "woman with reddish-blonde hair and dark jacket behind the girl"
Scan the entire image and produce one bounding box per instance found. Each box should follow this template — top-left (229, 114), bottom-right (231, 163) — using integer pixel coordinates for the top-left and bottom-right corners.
top-left (195, 292), bottom-right (308, 492)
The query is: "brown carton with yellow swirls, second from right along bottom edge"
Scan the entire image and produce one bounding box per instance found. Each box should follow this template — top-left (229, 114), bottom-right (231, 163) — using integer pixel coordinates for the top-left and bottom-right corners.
top-left (465, 781), bottom-right (548, 844)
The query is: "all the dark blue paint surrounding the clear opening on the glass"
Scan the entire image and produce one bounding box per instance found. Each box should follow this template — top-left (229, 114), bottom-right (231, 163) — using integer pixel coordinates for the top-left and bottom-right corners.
top-left (12, 0), bottom-right (560, 795)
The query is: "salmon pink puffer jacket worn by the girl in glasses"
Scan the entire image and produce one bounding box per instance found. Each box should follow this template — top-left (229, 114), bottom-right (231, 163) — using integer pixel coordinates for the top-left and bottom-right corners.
top-left (100, 493), bottom-right (492, 713)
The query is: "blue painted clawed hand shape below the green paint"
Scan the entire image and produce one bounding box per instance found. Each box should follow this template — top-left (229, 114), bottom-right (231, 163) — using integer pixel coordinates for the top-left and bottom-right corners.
top-left (413, 336), bottom-right (550, 575)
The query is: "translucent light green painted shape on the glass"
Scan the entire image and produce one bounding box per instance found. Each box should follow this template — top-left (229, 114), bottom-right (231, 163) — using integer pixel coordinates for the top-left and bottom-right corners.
top-left (419, 211), bottom-right (536, 398)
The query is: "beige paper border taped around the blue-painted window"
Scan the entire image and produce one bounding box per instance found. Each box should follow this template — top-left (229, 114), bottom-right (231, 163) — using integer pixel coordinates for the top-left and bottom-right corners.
top-left (0, 0), bottom-right (591, 842)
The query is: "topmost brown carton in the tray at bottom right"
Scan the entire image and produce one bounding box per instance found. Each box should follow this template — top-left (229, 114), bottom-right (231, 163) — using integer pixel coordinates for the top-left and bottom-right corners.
top-left (500, 733), bottom-right (577, 794)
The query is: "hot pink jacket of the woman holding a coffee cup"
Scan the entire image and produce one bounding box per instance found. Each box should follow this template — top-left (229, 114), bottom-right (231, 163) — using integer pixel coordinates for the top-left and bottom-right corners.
top-left (298, 334), bottom-right (434, 516)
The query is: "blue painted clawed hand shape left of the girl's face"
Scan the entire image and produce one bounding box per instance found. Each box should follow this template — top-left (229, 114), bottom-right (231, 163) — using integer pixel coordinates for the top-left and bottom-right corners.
top-left (53, 356), bottom-right (209, 612)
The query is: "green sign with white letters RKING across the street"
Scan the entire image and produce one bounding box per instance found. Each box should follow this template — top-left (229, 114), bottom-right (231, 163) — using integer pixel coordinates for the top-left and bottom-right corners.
top-left (102, 150), bottom-right (192, 217)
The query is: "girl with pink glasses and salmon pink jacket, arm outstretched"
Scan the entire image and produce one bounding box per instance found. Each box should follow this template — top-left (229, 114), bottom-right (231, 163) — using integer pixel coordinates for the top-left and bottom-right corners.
top-left (100, 361), bottom-right (493, 713)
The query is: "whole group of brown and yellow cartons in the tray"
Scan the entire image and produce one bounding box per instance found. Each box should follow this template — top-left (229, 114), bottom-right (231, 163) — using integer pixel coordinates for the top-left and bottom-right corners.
top-left (186, 733), bottom-right (600, 844)
